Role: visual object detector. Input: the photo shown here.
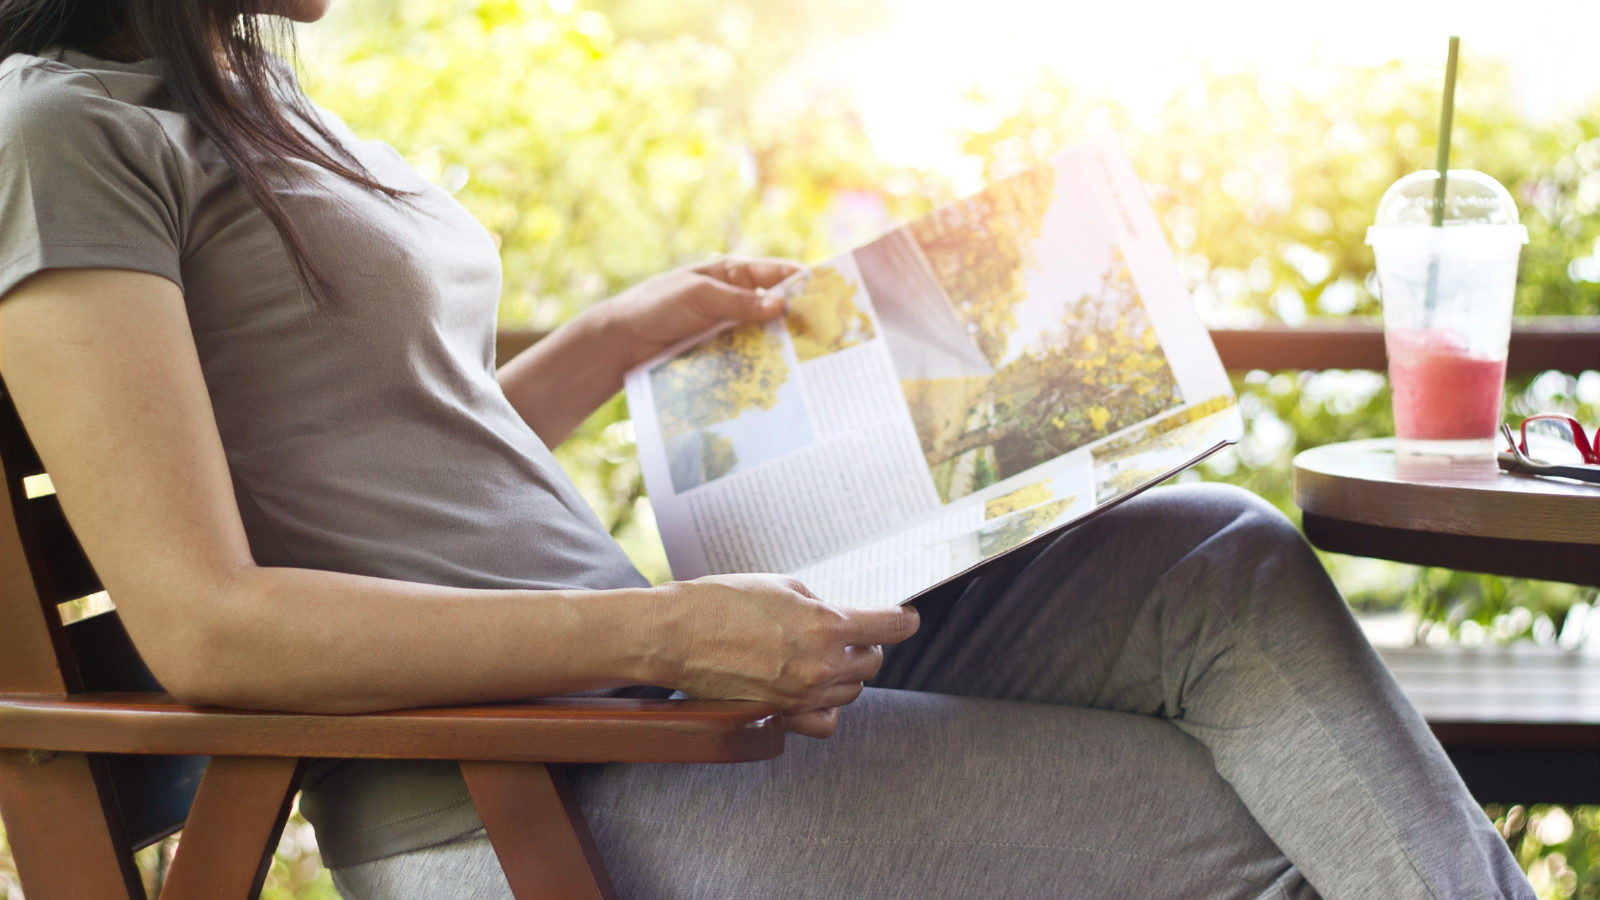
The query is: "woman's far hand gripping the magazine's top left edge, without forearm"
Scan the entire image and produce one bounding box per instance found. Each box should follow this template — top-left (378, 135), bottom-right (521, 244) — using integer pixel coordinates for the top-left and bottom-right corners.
top-left (595, 256), bottom-right (800, 368)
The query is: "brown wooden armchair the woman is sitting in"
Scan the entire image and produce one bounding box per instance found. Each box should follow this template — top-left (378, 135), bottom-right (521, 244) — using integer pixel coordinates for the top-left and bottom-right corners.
top-left (0, 384), bottom-right (784, 900)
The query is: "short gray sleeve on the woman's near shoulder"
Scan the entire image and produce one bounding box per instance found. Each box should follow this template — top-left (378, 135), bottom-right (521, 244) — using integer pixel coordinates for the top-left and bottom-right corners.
top-left (0, 58), bottom-right (184, 296)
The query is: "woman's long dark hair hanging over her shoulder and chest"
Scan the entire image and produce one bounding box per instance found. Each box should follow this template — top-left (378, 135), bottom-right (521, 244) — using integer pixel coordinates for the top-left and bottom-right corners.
top-left (0, 0), bottom-right (403, 303)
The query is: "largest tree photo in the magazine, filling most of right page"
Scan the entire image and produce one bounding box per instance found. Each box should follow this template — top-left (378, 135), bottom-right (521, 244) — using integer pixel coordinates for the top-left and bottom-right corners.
top-left (854, 157), bottom-right (1182, 503)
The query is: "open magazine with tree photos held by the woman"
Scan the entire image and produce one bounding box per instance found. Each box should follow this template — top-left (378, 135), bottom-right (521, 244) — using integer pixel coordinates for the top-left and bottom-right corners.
top-left (627, 138), bottom-right (1243, 607)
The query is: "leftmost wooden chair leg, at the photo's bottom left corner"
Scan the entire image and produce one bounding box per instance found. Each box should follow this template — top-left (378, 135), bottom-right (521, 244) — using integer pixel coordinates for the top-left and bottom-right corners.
top-left (0, 749), bottom-right (144, 900)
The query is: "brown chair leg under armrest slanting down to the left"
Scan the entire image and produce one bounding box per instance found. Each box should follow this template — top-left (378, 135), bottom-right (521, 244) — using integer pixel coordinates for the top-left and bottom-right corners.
top-left (162, 756), bottom-right (306, 900)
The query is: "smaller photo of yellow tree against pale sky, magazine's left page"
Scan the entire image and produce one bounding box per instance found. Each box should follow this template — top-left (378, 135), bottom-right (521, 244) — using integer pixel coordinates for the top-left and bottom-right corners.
top-left (650, 323), bottom-right (813, 493)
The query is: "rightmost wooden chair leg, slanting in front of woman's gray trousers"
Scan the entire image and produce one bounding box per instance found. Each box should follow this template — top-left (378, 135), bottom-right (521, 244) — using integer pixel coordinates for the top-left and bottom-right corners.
top-left (461, 762), bottom-right (616, 900)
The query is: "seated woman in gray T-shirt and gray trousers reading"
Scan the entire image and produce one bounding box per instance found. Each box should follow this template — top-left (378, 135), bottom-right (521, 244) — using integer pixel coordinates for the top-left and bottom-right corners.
top-left (0, 0), bottom-right (1531, 900)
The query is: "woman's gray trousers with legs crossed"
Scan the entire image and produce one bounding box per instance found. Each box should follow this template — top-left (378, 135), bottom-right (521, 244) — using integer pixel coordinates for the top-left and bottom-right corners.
top-left (333, 485), bottom-right (1533, 900)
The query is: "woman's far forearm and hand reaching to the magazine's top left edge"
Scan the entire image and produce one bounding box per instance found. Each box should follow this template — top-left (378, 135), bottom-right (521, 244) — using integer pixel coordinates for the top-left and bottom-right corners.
top-left (499, 258), bottom-right (798, 447)
